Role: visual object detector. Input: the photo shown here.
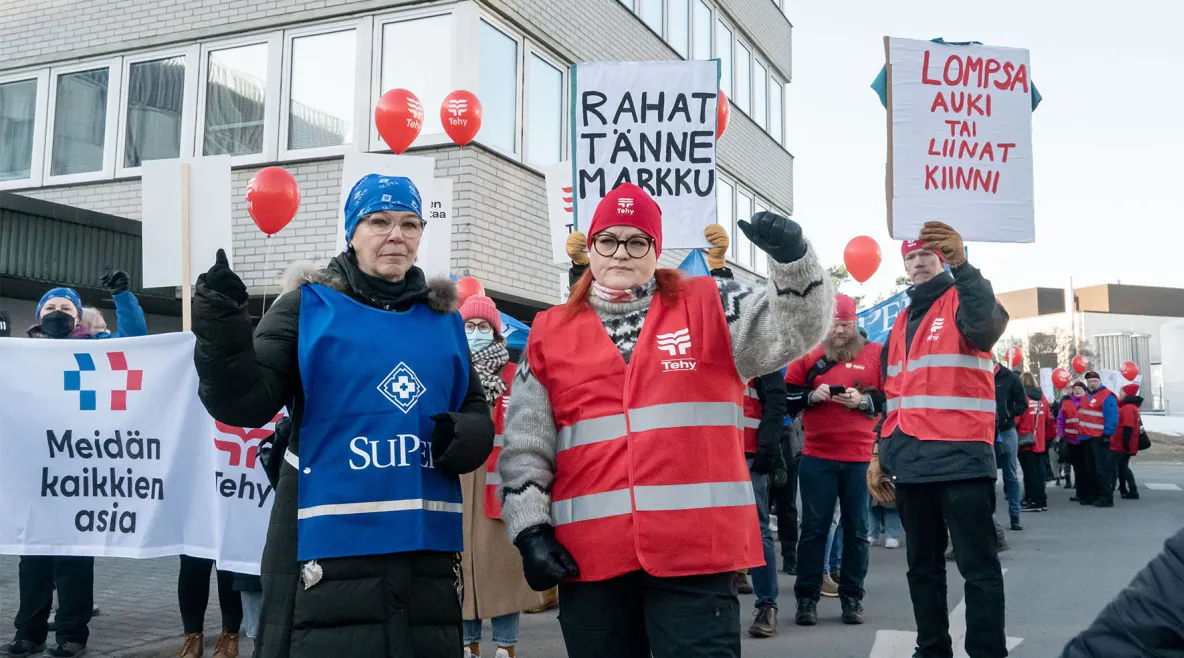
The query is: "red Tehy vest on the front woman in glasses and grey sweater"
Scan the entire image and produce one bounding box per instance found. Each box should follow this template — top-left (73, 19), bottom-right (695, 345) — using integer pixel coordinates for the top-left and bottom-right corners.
top-left (527, 277), bottom-right (765, 581)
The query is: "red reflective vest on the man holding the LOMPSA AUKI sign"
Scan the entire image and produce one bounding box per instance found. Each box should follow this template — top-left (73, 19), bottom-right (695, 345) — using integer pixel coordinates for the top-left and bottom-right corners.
top-left (880, 288), bottom-right (995, 444)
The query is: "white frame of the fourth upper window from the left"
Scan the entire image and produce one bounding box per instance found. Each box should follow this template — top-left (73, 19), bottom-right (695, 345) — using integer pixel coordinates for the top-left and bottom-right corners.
top-left (193, 31), bottom-right (284, 167)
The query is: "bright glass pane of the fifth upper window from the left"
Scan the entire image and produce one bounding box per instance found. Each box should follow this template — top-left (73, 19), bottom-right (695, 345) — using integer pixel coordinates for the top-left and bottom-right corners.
top-left (283, 30), bottom-right (358, 150)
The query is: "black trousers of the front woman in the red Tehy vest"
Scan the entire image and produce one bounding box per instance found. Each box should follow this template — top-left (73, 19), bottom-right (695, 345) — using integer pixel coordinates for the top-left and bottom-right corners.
top-left (559, 572), bottom-right (740, 658)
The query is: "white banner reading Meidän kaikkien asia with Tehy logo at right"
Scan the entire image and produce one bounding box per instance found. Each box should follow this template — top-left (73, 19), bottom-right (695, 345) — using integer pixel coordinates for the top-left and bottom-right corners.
top-left (0, 334), bottom-right (274, 574)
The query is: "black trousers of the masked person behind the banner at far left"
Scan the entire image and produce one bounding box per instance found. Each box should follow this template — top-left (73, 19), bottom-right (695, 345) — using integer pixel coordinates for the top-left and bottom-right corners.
top-left (15, 555), bottom-right (95, 644)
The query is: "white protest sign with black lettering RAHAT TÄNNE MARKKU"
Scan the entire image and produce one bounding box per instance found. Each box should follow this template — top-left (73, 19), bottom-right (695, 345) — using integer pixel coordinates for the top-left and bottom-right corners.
top-left (571, 60), bottom-right (719, 249)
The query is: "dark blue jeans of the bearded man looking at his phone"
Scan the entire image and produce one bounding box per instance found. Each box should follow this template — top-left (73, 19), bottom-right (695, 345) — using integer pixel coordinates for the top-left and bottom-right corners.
top-left (793, 454), bottom-right (868, 600)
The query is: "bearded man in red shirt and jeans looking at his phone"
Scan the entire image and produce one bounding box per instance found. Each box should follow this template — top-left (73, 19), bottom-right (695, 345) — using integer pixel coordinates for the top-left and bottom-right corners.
top-left (785, 295), bottom-right (884, 626)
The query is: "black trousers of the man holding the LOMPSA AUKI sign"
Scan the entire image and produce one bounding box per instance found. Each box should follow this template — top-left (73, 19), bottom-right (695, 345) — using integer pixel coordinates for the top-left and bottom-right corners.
top-left (896, 478), bottom-right (1008, 658)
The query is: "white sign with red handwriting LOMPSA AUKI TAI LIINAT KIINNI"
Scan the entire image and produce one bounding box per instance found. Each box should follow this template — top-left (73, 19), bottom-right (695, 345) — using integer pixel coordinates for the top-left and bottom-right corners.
top-left (884, 37), bottom-right (1036, 243)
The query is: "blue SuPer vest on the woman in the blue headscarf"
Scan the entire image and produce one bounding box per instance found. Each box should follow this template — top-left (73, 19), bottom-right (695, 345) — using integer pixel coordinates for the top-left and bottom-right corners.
top-left (296, 284), bottom-right (469, 561)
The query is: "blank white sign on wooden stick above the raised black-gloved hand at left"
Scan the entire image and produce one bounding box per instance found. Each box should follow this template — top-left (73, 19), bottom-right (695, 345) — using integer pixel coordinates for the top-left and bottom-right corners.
top-left (140, 155), bottom-right (234, 288)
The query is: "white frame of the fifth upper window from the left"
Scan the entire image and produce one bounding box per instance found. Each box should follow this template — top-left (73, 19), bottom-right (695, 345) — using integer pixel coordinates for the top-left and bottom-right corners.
top-left (277, 17), bottom-right (374, 162)
